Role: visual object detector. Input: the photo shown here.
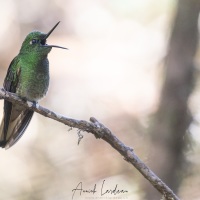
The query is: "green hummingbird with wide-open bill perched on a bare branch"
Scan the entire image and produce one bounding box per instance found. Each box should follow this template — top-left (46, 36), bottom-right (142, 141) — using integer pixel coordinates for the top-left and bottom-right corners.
top-left (0, 22), bottom-right (67, 149)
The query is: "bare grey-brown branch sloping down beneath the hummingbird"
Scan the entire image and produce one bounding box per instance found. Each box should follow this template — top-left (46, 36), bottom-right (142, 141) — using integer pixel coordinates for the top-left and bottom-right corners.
top-left (0, 88), bottom-right (179, 200)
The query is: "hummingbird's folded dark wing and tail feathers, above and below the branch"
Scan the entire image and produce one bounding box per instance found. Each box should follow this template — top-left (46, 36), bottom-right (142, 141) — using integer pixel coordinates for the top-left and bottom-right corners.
top-left (0, 57), bottom-right (34, 148)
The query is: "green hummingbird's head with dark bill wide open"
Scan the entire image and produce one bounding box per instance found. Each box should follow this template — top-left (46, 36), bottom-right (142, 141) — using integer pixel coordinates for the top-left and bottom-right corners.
top-left (20, 22), bottom-right (67, 55)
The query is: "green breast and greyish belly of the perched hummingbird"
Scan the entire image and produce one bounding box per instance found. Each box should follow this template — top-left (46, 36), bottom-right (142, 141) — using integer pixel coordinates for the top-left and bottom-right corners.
top-left (16, 58), bottom-right (49, 101)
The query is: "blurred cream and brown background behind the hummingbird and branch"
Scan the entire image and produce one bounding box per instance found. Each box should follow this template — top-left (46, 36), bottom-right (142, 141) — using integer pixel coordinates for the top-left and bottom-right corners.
top-left (0, 0), bottom-right (200, 200)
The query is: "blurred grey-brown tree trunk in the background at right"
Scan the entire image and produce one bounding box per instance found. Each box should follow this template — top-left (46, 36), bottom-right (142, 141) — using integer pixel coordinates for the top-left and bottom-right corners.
top-left (145, 0), bottom-right (200, 200)
